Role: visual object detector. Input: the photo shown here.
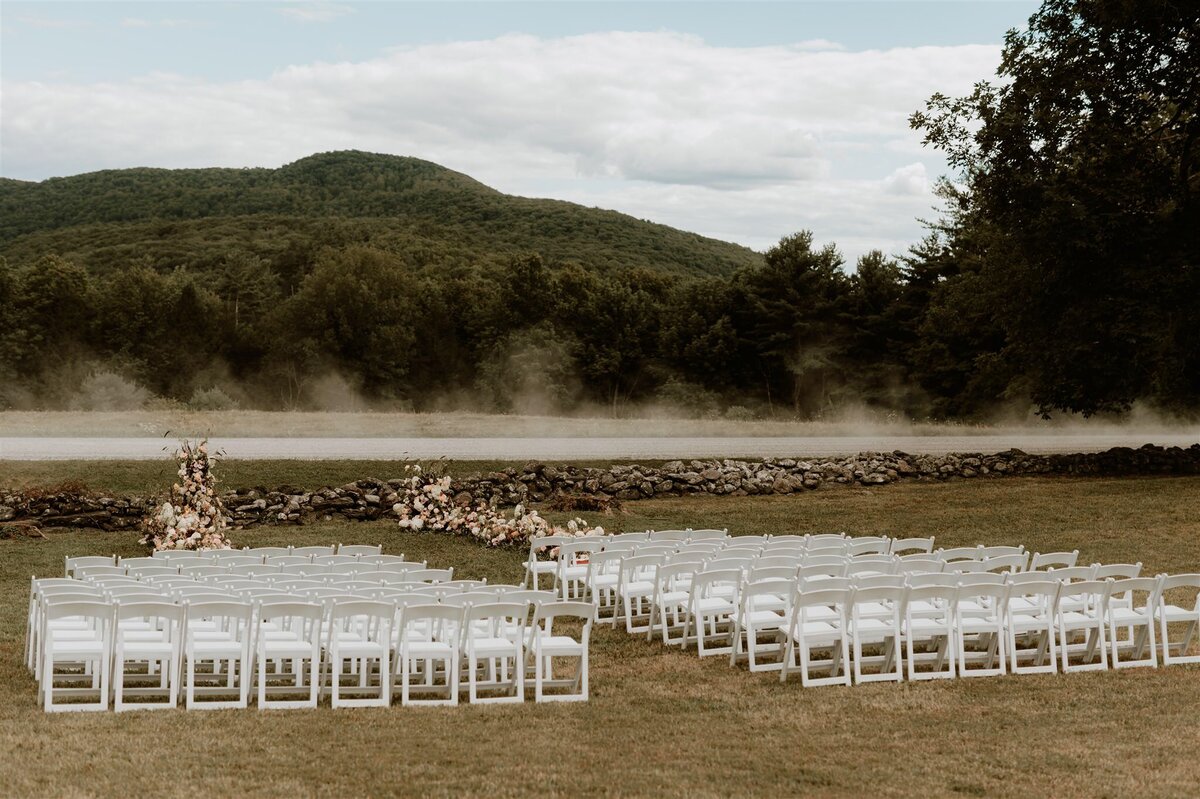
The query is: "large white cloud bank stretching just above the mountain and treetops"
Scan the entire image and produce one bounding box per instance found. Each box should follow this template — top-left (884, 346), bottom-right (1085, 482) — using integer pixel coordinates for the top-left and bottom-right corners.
top-left (0, 32), bottom-right (1000, 260)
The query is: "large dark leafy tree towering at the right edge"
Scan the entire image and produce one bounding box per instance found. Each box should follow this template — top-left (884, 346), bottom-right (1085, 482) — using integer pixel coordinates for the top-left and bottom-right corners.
top-left (911, 0), bottom-right (1200, 413)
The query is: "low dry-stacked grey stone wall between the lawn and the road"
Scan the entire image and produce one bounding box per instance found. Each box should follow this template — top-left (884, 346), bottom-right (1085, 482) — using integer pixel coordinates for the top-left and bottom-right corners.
top-left (0, 444), bottom-right (1200, 530)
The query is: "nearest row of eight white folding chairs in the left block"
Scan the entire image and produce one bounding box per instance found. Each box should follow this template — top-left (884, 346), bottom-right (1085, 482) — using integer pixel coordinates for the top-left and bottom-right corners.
top-left (40, 591), bottom-right (592, 710)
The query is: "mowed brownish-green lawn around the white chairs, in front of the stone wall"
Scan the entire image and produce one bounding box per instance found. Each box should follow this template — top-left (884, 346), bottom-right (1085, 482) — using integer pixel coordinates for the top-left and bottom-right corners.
top-left (0, 479), bottom-right (1200, 797)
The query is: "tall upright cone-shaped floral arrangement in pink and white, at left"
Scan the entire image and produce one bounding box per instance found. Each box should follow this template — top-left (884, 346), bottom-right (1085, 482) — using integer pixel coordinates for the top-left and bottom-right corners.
top-left (142, 440), bottom-right (232, 549)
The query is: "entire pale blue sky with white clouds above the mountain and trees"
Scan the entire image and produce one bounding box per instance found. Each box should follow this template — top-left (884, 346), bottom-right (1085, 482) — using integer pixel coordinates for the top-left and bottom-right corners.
top-left (0, 0), bottom-right (1037, 263)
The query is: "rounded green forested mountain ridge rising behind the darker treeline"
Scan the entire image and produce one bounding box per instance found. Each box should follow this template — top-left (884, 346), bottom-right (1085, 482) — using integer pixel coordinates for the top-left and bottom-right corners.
top-left (0, 151), bottom-right (762, 276)
